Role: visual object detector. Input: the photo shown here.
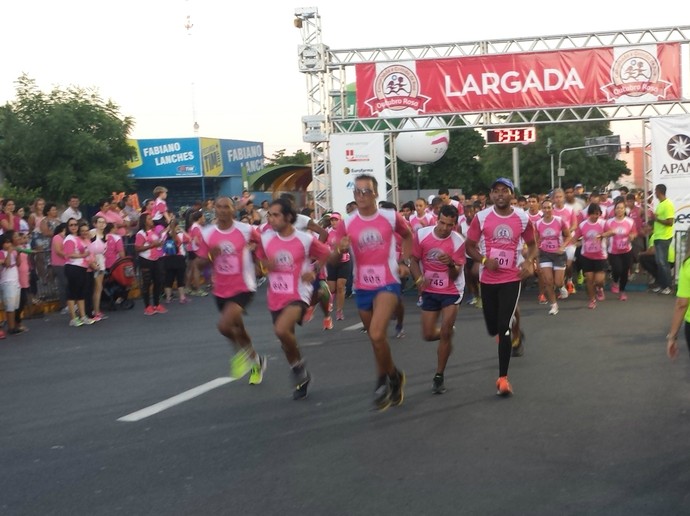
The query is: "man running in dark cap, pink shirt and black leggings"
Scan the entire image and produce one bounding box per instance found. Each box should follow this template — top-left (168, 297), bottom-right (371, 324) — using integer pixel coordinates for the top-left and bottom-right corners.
top-left (466, 177), bottom-right (537, 396)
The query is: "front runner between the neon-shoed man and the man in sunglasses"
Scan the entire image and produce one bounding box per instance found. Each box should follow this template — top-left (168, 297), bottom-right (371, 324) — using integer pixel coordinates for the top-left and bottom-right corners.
top-left (257, 199), bottom-right (330, 400)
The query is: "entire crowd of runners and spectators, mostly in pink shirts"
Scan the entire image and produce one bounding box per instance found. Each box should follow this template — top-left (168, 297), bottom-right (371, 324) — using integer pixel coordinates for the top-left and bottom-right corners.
top-left (0, 179), bottom-right (690, 410)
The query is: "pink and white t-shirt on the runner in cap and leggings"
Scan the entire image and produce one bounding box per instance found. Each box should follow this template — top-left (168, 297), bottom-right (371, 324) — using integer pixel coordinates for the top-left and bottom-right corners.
top-left (467, 207), bottom-right (534, 284)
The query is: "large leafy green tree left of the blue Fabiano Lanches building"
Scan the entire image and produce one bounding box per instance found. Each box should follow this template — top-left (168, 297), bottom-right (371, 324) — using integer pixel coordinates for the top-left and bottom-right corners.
top-left (0, 75), bottom-right (133, 203)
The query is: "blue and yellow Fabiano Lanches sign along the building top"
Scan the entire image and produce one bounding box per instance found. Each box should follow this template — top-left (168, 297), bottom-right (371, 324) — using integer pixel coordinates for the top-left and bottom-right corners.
top-left (128, 138), bottom-right (264, 179)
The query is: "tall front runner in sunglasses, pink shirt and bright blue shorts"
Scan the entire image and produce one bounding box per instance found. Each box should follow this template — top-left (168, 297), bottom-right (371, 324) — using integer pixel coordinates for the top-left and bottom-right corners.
top-left (329, 175), bottom-right (412, 410)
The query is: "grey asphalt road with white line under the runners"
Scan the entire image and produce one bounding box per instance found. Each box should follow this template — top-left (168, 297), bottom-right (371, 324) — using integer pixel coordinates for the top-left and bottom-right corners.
top-left (0, 284), bottom-right (690, 516)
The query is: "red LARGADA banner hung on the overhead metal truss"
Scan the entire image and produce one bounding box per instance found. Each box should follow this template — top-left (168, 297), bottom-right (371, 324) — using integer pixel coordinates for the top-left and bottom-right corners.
top-left (355, 43), bottom-right (682, 118)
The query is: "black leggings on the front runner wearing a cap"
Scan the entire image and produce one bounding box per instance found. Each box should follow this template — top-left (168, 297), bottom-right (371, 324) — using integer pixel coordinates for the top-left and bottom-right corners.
top-left (481, 281), bottom-right (522, 376)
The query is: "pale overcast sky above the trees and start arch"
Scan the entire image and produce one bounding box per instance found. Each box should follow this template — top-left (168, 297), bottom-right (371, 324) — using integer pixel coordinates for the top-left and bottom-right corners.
top-left (0, 0), bottom-right (690, 157)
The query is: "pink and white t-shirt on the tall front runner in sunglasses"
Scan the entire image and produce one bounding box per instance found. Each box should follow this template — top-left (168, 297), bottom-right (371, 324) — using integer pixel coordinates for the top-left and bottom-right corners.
top-left (335, 208), bottom-right (410, 290)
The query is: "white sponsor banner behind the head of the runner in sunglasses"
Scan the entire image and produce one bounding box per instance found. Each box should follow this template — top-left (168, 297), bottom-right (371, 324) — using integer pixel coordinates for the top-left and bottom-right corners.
top-left (330, 133), bottom-right (388, 215)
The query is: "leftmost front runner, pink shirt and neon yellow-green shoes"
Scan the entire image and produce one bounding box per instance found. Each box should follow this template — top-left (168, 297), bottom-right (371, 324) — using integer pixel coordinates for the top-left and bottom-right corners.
top-left (196, 197), bottom-right (267, 385)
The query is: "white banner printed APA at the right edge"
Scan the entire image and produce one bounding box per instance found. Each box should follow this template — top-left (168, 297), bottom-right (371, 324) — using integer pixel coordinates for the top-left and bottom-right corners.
top-left (649, 115), bottom-right (690, 231)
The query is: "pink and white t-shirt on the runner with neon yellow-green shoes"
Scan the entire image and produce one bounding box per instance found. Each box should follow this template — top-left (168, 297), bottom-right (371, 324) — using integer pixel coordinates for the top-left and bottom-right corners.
top-left (197, 221), bottom-right (260, 299)
